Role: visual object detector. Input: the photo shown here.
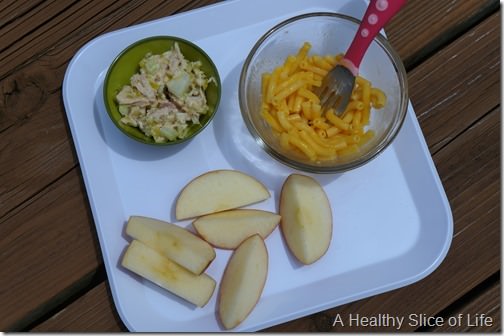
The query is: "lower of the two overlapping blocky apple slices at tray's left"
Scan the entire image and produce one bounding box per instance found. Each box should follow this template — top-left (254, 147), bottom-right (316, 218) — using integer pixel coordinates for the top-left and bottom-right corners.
top-left (122, 240), bottom-right (216, 307)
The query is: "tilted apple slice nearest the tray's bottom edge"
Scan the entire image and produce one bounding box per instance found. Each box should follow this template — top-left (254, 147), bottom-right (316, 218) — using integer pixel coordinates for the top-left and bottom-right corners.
top-left (218, 235), bottom-right (268, 329)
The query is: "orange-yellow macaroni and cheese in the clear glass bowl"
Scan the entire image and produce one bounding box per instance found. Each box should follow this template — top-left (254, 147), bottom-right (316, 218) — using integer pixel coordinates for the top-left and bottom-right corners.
top-left (261, 42), bottom-right (387, 161)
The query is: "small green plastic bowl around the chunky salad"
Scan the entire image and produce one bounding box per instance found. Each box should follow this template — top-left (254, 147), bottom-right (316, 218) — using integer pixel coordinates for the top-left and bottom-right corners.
top-left (103, 36), bottom-right (221, 146)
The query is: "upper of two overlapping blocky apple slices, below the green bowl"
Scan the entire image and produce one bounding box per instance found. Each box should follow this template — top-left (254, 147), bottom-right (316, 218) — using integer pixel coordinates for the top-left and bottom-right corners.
top-left (126, 216), bottom-right (215, 274)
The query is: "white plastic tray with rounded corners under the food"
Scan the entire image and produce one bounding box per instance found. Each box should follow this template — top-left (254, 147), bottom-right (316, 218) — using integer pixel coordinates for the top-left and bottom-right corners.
top-left (63, 0), bottom-right (453, 332)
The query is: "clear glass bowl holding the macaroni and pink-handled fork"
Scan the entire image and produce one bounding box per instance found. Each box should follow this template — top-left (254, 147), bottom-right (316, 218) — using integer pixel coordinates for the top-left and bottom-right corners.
top-left (239, 13), bottom-right (408, 173)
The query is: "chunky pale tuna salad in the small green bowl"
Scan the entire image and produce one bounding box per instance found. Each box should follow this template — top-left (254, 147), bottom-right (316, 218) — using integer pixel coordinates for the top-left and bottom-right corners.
top-left (116, 43), bottom-right (215, 143)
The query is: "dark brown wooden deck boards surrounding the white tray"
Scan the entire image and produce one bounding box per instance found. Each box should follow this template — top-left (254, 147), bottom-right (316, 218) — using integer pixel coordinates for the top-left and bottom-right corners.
top-left (0, 0), bottom-right (501, 332)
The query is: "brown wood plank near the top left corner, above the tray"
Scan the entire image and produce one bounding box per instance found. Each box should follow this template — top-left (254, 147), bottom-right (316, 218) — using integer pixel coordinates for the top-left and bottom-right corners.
top-left (0, 0), bottom-right (222, 79)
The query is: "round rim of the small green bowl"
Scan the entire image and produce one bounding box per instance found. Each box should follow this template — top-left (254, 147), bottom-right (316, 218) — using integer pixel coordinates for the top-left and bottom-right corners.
top-left (102, 35), bottom-right (222, 147)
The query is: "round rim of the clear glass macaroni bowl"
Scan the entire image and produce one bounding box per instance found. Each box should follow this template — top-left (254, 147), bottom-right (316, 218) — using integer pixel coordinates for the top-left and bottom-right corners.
top-left (238, 12), bottom-right (409, 174)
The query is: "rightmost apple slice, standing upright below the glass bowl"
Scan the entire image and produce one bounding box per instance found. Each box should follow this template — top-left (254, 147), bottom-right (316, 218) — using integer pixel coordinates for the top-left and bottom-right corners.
top-left (280, 174), bottom-right (332, 264)
